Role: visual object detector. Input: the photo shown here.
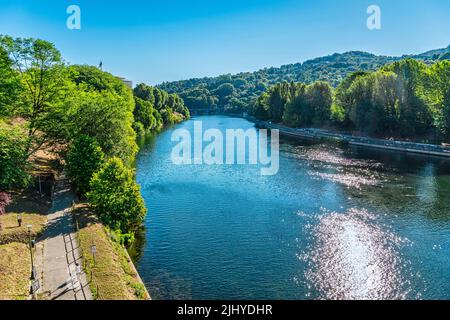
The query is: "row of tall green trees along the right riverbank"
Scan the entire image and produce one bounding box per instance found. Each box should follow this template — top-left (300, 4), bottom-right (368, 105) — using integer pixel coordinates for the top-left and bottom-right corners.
top-left (249, 59), bottom-right (450, 141)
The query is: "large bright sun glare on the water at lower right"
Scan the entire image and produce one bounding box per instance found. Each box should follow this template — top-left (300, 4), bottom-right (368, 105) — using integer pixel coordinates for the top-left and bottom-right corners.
top-left (299, 209), bottom-right (410, 299)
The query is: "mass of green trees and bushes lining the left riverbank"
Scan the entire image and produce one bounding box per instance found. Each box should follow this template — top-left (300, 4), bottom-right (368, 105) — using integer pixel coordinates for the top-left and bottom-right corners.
top-left (0, 36), bottom-right (189, 240)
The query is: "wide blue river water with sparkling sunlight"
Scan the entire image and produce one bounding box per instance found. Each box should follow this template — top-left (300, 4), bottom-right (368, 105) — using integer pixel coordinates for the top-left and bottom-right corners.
top-left (136, 116), bottom-right (450, 299)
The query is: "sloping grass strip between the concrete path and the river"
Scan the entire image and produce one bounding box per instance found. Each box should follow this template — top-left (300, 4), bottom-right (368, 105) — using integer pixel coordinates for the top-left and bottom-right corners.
top-left (74, 205), bottom-right (148, 300)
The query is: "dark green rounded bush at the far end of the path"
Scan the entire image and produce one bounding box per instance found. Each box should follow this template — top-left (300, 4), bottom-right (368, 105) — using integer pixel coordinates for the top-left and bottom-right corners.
top-left (67, 135), bottom-right (104, 195)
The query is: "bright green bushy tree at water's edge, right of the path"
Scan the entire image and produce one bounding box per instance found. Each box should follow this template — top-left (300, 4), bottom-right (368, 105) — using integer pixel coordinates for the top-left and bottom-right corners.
top-left (88, 158), bottom-right (146, 233)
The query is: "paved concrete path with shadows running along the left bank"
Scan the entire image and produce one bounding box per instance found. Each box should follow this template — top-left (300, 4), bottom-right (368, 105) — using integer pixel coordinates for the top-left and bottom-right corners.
top-left (36, 175), bottom-right (92, 300)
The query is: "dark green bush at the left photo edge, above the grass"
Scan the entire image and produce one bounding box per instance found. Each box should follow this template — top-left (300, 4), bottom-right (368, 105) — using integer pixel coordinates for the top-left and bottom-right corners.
top-left (0, 123), bottom-right (30, 190)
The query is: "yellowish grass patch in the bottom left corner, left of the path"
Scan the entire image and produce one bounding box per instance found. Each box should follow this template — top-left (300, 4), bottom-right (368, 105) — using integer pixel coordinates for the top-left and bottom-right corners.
top-left (0, 243), bottom-right (31, 300)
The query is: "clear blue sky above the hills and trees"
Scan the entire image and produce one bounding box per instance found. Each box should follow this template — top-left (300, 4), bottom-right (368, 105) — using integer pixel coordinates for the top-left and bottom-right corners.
top-left (0, 0), bottom-right (450, 85)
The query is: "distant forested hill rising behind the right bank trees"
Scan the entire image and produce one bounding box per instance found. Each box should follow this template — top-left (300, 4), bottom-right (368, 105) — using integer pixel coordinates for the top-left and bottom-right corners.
top-left (158, 46), bottom-right (450, 112)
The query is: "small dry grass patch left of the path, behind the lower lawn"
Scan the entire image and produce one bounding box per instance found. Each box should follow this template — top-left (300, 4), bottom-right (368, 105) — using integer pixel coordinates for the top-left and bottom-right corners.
top-left (0, 213), bottom-right (47, 244)
